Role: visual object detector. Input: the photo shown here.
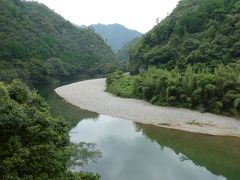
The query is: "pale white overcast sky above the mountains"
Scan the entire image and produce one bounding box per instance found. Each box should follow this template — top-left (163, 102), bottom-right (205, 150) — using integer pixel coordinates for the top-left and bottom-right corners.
top-left (36, 0), bottom-right (179, 33)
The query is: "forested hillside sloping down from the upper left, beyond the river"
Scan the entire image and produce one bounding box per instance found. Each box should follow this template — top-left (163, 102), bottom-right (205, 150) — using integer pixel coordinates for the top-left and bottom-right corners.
top-left (0, 0), bottom-right (117, 85)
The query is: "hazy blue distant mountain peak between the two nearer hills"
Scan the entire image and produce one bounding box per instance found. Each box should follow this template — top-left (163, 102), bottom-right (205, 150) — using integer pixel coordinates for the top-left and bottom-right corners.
top-left (90, 24), bottom-right (142, 53)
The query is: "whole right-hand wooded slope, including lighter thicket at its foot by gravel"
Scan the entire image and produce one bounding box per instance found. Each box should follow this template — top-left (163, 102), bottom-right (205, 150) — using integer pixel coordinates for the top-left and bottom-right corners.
top-left (107, 0), bottom-right (240, 116)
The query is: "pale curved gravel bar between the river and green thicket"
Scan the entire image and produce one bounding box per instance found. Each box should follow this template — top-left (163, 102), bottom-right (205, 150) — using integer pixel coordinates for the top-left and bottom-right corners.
top-left (55, 78), bottom-right (240, 137)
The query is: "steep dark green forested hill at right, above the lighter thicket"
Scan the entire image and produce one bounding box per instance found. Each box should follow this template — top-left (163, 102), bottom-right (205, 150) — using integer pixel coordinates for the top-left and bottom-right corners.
top-left (129, 0), bottom-right (240, 73)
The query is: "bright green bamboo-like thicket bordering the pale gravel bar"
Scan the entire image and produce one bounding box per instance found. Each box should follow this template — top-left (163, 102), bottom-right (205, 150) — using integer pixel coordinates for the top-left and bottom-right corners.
top-left (107, 62), bottom-right (240, 116)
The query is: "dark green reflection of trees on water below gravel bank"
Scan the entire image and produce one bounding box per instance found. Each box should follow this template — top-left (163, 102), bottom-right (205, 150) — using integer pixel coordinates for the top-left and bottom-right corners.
top-left (135, 123), bottom-right (240, 180)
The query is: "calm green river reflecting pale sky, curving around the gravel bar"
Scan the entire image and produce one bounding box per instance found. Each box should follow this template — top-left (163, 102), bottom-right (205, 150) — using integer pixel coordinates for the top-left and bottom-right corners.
top-left (41, 89), bottom-right (240, 180)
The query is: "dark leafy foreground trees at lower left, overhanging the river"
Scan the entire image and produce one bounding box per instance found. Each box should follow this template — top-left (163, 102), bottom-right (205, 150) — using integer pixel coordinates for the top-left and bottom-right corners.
top-left (0, 80), bottom-right (101, 179)
